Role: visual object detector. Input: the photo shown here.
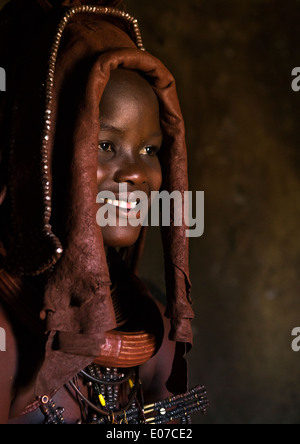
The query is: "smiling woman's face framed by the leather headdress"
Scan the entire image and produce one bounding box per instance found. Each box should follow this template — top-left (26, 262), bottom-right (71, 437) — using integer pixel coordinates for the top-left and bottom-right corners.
top-left (97, 69), bottom-right (162, 247)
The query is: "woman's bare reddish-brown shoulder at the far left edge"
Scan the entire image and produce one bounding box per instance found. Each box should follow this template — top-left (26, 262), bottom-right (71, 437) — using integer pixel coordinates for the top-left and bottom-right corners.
top-left (0, 304), bottom-right (17, 424)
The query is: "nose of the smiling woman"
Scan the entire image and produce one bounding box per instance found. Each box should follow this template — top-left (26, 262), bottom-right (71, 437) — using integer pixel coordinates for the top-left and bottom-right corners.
top-left (114, 158), bottom-right (147, 185)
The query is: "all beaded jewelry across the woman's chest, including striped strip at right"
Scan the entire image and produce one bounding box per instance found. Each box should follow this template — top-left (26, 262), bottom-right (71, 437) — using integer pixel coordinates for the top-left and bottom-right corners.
top-left (40, 364), bottom-right (209, 424)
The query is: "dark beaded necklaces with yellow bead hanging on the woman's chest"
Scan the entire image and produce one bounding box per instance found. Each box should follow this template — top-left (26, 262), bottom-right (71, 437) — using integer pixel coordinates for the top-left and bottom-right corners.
top-left (40, 364), bottom-right (145, 424)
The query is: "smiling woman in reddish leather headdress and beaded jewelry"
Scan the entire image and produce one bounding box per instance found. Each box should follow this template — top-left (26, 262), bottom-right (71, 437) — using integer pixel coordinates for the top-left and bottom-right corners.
top-left (0, 0), bottom-right (205, 423)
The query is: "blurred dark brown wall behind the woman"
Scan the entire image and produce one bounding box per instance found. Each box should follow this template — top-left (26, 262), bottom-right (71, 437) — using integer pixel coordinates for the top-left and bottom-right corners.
top-left (0, 0), bottom-right (300, 424)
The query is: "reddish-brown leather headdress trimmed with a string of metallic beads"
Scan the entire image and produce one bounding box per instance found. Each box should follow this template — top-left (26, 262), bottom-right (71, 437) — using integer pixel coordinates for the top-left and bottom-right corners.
top-left (0, 0), bottom-right (193, 396)
